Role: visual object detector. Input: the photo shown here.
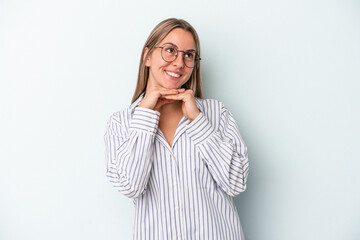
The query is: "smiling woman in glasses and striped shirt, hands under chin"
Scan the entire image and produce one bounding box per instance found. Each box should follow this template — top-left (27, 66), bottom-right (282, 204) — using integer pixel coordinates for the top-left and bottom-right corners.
top-left (105, 18), bottom-right (249, 240)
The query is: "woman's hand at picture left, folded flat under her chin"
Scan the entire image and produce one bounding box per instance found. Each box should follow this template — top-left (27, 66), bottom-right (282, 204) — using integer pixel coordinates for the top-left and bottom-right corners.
top-left (139, 87), bottom-right (185, 111)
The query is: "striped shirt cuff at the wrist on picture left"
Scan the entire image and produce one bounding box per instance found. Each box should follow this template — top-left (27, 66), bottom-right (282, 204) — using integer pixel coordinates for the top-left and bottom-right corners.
top-left (130, 107), bottom-right (160, 134)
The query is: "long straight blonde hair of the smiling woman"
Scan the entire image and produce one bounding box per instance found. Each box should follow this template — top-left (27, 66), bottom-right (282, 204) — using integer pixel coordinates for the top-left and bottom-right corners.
top-left (131, 18), bottom-right (202, 103)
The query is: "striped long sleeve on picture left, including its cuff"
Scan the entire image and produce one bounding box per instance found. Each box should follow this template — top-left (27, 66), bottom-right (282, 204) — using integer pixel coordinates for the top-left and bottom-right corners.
top-left (104, 107), bottom-right (160, 198)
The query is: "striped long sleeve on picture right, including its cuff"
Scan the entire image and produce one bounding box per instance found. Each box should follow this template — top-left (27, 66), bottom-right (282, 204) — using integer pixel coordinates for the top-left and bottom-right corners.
top-left (187, 104), bottom-right (249, 196)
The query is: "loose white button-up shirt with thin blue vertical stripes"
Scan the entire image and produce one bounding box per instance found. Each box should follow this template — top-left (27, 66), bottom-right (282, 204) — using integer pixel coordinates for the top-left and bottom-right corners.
top-left (105, 96), bottom-right (249, 240)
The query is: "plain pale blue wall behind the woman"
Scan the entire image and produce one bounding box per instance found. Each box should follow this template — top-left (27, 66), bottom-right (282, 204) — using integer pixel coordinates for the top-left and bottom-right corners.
top-left (0, 0), bottom-right (360, 240)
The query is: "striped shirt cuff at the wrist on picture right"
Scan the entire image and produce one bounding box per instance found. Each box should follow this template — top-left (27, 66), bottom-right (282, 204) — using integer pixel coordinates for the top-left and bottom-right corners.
top-left (186, 112), bottom-right (215, 144)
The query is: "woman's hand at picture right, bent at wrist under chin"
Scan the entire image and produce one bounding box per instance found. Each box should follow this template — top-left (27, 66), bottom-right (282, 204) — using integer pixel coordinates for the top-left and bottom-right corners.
top-left (163, 89), bottom-right (200, 121)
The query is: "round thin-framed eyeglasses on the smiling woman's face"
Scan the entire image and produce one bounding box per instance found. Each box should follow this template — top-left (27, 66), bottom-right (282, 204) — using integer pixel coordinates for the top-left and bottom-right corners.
top-left (154, 44), bottom-right (201, 68)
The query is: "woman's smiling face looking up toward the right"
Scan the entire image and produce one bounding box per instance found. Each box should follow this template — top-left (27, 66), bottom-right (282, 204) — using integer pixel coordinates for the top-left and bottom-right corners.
top-left (145, 28), bottom-right (196, 89)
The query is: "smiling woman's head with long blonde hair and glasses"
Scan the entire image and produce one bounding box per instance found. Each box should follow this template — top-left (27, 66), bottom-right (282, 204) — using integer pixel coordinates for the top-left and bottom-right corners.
top-left (132, 18), bottom-right (202, 102)
